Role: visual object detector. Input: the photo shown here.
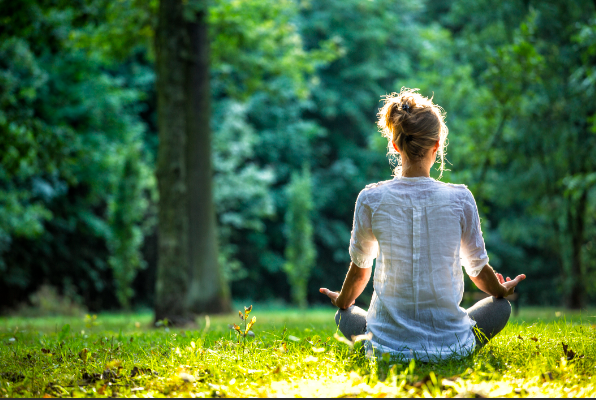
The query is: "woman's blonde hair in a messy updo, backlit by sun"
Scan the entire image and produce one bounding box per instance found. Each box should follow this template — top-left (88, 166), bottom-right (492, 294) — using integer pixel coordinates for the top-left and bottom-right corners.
top-left (377, 88), bottom-right (449, 179)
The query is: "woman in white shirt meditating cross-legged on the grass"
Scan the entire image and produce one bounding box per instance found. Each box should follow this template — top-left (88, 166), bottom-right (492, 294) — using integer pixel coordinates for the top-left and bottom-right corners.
top-left (320, 90), bottom-right (525, 361)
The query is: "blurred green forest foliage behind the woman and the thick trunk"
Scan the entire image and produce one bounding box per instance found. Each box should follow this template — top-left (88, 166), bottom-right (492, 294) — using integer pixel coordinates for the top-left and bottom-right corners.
top-left (0, 0), bottom-right (596, 312)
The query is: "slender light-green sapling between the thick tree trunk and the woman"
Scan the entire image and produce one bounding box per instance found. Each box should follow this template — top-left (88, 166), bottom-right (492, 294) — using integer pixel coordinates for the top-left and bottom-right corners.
top-left (284, 166), bottom-right (317, 308)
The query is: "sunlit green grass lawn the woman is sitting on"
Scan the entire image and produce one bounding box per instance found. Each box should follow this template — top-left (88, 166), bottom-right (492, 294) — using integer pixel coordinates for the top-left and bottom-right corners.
top-left (0, 306), bottom-right (596, 397)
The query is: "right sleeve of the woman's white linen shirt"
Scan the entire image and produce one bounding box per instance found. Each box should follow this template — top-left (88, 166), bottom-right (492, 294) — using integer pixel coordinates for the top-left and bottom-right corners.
top-left (461, 189), bottom-right (488, 277)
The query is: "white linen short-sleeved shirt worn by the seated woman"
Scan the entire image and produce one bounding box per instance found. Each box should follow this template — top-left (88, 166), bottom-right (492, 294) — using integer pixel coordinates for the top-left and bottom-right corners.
top-left (350, 177), bottom-right (488, 361)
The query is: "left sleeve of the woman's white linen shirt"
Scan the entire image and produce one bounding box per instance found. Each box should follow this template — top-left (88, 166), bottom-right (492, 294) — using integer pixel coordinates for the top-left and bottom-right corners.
top-left (350, 191), bottom-right (379, 268)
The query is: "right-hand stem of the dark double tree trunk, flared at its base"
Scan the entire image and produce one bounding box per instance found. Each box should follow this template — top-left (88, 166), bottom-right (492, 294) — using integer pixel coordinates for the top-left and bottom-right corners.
top-left (186, 10), bottom-right (231, 313)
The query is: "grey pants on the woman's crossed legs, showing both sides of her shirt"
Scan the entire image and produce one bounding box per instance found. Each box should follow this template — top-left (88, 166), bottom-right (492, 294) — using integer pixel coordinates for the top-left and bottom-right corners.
top-left (335, 296), bottom-right (511, 347)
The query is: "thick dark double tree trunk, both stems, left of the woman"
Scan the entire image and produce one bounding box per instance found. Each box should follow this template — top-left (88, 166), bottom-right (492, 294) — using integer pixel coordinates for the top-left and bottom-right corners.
top-left (155, 0), bottom-right (229, 324)
